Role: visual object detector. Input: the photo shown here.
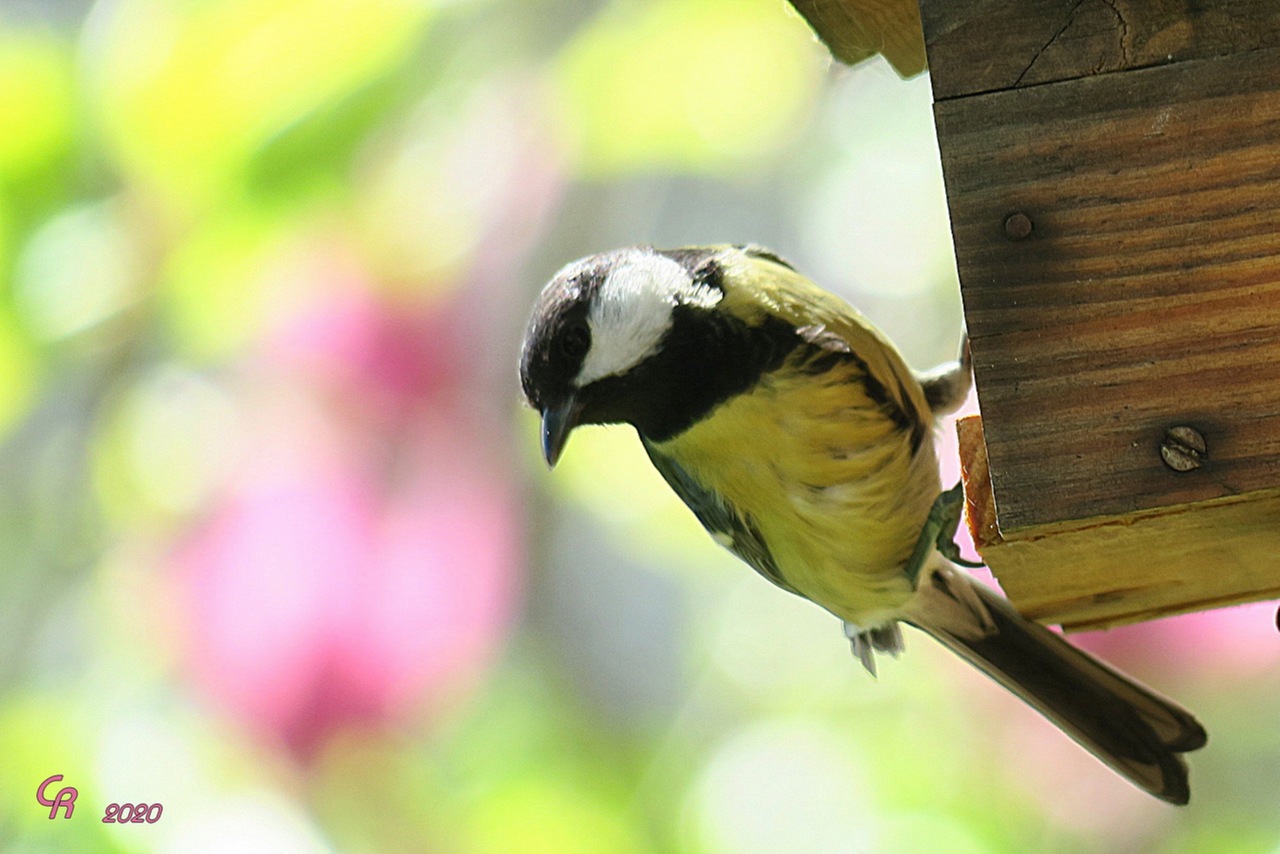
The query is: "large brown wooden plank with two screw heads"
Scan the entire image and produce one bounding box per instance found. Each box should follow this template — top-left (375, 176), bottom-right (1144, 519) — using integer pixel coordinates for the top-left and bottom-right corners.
top-left (936, 50), bottom-right (1280, 539)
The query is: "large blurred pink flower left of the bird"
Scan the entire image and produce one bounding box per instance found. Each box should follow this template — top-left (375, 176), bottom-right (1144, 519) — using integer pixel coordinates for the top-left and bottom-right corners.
top-left (177, 288), bottom-right (521, 757)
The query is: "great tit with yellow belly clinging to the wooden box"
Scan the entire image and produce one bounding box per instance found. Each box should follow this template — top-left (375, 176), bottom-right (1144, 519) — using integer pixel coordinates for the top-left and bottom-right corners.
top-left (520, 246), bottom-right (1206, 804)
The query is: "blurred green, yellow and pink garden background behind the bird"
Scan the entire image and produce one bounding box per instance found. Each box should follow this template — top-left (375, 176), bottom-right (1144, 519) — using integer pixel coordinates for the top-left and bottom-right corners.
top-left (0, 0), bottom-right (1280, 854)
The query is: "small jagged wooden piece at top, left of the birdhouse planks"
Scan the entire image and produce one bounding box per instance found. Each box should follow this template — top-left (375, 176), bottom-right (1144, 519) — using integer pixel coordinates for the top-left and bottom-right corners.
top-left (791, 0), bottom-right (925, 77)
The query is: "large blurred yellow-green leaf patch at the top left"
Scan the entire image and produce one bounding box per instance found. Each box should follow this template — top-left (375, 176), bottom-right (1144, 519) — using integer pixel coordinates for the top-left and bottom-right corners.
top-left (91, 0), bottom-right (430, 214)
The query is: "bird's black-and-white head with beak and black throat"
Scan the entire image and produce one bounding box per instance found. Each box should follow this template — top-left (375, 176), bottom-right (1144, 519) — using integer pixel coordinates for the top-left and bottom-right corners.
top-left (520, 247), bottom-right (795, 465)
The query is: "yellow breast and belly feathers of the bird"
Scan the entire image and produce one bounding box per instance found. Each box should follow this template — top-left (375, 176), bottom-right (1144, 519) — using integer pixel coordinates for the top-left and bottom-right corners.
top-left (658, 350), bottom-right (940, 625)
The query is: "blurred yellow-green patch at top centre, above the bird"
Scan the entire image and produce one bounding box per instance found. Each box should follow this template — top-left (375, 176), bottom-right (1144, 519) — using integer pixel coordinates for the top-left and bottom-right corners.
top-left (558, 0), bottom-right (822, 175)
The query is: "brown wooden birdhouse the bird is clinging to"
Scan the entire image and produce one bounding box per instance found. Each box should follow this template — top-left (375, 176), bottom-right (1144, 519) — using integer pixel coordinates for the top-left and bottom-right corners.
top-left (796, 0), bottom-right (1280, 629)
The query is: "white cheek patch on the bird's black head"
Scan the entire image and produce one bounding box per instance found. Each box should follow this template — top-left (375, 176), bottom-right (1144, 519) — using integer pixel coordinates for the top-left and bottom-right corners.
top-left (577, 250), bottom-right (723, 387)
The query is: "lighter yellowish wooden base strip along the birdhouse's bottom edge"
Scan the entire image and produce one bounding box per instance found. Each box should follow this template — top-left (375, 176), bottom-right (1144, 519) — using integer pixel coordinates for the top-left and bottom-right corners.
top-left (956, 416), bottom-right (1280, 631)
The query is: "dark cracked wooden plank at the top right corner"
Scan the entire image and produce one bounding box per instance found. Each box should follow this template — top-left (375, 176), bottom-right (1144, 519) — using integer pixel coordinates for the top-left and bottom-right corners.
top-left (920, 0), bottom-right (1280, 101)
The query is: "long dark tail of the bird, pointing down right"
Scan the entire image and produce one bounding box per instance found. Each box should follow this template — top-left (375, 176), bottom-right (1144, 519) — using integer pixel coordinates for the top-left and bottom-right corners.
top-left (904, 567), bottom-right (1207, 804)
